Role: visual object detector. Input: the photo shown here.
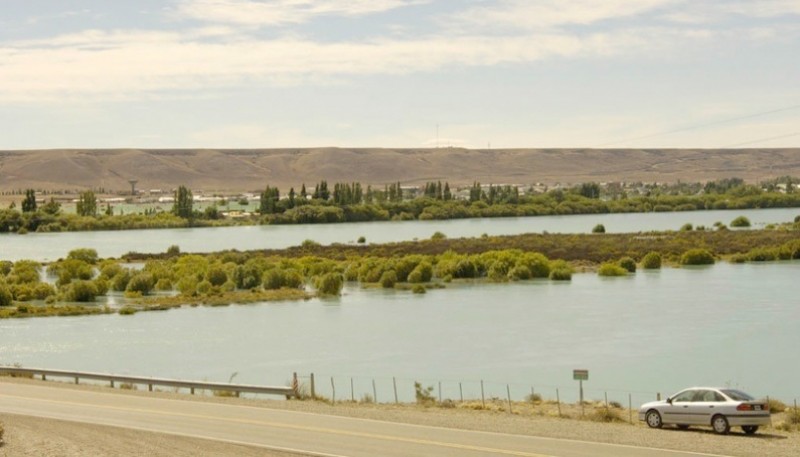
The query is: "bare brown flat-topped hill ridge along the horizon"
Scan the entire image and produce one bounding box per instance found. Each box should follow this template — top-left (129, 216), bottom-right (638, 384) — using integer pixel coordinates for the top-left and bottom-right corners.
top-left (0, 148), bottom-right (800, 192)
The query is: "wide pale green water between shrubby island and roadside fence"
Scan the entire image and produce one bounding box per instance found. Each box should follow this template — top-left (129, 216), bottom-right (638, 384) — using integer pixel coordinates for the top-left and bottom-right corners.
top-left (0, 262), bottom-right (800, 403)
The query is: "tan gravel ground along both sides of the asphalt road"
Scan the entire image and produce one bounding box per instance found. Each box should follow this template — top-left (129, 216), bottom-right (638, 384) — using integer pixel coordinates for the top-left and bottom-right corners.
top-left (0, 378), bottom-right (800, 457)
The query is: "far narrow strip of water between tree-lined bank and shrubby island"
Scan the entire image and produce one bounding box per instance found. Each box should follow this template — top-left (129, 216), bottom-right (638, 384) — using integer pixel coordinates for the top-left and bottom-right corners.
top-left (0, 208), bottom-right (800, 260)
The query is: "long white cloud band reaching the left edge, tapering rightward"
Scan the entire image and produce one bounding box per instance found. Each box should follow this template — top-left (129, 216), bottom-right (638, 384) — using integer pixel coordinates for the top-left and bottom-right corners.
top-left (0, 30), bottom-right (644, 101)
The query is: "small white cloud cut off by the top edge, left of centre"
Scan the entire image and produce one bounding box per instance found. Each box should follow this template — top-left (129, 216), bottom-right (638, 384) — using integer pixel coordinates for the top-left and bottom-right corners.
top-left (177, 0), bottom-right (422, 26)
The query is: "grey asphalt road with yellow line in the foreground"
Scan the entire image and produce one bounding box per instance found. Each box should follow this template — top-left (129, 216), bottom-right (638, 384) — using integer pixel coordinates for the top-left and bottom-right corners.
top-left (0, 383), bottom-right (732, 457)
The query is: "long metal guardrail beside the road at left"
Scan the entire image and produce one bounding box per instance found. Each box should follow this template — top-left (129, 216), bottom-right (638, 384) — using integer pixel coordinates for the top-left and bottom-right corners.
top-left (0, 367), bottom-right (297, 398)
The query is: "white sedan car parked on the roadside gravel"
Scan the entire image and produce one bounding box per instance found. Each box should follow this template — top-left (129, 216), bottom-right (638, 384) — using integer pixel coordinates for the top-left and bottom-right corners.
top-left (639, 387), bottom-right (770, 435)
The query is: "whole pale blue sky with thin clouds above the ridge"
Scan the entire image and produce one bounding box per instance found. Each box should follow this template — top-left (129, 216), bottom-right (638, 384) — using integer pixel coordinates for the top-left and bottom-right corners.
top-left (0, 0), bottom-right (800, 149)
